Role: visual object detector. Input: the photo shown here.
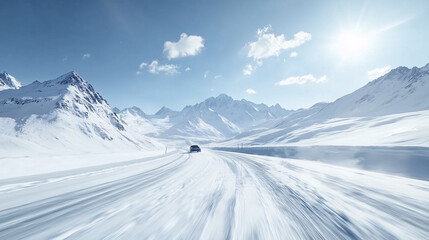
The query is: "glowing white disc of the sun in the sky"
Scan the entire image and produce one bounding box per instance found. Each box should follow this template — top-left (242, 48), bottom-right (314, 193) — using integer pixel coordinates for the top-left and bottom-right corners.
top-left (336, 31), bottom-right (369, 58)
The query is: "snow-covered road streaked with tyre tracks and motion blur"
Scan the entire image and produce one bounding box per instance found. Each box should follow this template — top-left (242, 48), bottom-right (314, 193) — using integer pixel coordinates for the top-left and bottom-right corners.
top-left (0, 149), bottom-right (429, 240)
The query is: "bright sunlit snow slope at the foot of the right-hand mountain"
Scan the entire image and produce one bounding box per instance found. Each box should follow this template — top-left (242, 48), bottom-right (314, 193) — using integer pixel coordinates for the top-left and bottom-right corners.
top-left (226, 110), bottom-right (429, 147)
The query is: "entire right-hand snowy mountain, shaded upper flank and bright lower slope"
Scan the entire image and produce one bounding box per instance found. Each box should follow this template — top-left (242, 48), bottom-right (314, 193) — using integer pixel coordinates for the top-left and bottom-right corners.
top-left (228, 64), bottom-right (429, 146)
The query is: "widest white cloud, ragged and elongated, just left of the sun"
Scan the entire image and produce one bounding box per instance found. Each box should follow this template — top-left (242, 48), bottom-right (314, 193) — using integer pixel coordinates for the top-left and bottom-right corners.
top-left (247, 25), bottom-right (311, 60)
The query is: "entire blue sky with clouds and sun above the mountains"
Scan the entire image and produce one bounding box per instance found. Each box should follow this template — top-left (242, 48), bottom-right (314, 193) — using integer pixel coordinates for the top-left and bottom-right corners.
top-left (0, 0), bottom-right (429, 113)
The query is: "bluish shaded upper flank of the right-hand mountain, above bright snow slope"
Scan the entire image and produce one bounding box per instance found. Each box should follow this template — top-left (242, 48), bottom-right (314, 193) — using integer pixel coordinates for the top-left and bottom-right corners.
top-left (315, 64), bottom-right (429, 118)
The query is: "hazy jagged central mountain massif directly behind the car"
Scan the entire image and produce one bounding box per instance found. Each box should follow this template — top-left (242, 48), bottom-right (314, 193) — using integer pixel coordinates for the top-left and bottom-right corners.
top-left (164, 94), bottom-right (289, 139)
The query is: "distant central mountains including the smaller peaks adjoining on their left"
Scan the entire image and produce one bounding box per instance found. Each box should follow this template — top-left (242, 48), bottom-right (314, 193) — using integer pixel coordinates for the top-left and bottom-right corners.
top-left (120, 94), bottom-right (291, 141)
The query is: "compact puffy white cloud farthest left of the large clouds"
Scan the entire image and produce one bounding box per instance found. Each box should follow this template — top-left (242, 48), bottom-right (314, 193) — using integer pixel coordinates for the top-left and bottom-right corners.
top-left (164, 33), bottom-right (204, 60)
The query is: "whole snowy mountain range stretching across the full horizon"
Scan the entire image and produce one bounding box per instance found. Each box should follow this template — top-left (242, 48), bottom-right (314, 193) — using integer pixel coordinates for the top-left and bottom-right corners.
top-left (0, 64), bottom-right (429, 152)
